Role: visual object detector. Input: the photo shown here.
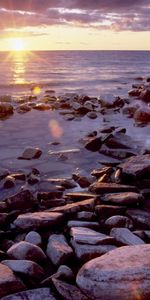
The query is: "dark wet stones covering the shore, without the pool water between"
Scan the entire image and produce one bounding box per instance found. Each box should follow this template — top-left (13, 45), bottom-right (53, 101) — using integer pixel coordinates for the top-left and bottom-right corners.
top-left (0, 78), bottom-right (150, 300)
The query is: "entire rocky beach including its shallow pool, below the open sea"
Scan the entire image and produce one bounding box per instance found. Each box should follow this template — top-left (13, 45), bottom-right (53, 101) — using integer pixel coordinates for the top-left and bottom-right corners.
top-left (0, 73), bottom-right (150, 300)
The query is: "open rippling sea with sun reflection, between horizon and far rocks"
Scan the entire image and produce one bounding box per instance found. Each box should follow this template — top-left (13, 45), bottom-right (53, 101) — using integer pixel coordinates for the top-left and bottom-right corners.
top-left (0, 51), bottom-right (150, 96)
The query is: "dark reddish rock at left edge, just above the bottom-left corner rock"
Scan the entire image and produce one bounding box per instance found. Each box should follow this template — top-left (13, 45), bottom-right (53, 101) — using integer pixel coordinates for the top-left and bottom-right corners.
top-left (0, 264), bottom-right (26, 297)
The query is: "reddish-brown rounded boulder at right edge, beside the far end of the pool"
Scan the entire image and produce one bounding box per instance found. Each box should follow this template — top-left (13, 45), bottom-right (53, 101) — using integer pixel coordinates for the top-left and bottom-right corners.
top-left (133, 107), bottom-right (150, 124)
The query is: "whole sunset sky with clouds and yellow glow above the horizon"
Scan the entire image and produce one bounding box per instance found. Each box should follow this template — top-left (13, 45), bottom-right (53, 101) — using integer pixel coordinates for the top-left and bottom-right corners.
top-left (0, 0), bottom-right (150, 51)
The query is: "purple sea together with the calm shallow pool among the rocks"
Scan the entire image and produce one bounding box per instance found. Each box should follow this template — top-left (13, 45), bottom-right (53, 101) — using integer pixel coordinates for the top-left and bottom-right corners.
top-left (0, 51), bottom-right (150, 199)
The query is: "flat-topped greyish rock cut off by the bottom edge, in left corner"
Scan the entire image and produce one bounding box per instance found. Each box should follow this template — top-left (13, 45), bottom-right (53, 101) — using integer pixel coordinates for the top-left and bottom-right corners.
top-left (1, 288), bottom-right (57, 300)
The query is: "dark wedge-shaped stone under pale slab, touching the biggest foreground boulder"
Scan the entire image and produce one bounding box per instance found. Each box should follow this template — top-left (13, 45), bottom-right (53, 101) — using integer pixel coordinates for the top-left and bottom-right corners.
top-left (71, 241), bottom-right (116, 262)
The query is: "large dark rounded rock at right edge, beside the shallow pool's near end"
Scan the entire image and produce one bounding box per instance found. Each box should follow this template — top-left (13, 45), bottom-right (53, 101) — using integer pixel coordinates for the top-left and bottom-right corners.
top-left (119, 154), bottom-right (150, 179)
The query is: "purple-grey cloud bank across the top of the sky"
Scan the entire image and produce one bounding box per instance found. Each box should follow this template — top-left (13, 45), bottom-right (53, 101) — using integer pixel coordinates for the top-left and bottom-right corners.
top-left (0, 0), bottom-right (150, 35)
